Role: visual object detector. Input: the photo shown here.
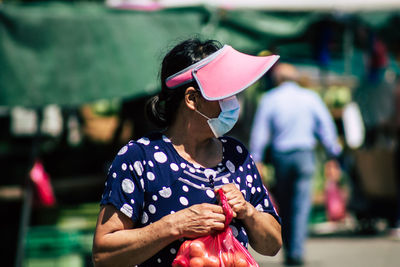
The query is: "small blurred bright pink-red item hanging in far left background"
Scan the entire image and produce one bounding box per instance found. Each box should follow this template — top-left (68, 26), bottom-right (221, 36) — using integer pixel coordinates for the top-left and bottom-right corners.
top-left (29, 160), bottom-right (56, 206)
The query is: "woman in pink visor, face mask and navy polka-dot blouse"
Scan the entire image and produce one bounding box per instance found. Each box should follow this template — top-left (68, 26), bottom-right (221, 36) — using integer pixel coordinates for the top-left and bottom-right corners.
top-left (93, 39), bottom-right (282, 267)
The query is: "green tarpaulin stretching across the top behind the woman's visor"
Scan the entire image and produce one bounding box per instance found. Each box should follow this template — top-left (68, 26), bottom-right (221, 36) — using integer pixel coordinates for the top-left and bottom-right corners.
top-left (0, 2), bottom-right (400, 107)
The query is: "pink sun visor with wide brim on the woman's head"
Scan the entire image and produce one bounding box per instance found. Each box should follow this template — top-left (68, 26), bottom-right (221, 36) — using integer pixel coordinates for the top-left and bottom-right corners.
top-left (165, 45), bottom-right (279, 100)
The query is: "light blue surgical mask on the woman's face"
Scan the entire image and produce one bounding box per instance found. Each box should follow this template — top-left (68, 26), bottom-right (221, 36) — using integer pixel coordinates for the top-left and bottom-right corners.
top-left (196, 96), bottom-right (240, 138)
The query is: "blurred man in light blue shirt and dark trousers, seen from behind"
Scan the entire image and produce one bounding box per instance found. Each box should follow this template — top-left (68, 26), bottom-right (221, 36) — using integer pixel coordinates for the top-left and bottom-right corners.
top-left (250, 63), bottom-right (341, 265)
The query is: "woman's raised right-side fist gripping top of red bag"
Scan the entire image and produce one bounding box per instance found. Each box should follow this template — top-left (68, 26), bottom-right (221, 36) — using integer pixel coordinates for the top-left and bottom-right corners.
top-left (216, 184), bottom-right (254, 219)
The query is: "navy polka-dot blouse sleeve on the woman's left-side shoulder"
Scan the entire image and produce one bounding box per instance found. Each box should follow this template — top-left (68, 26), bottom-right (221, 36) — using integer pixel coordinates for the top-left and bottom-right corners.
top-left (100, 142), bottom-right (144, 222)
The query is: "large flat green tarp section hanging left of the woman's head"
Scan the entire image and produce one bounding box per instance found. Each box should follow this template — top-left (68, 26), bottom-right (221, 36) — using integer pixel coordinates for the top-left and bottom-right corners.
top-left (0, 4), bottom-right (211, 106)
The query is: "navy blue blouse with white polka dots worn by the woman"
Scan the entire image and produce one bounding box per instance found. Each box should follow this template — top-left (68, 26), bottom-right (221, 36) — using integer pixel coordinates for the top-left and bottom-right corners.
top-left (101, 133), bottom-right (280, 266)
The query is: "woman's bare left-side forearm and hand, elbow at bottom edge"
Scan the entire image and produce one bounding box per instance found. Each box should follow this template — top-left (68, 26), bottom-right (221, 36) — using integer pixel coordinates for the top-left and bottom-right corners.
top-left (93, 203), bottom-right (225, 267)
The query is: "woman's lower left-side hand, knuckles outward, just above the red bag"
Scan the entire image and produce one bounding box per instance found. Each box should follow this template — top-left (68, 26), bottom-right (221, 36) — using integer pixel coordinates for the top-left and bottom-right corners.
top-left (169, 203), bottom-right (225, 238)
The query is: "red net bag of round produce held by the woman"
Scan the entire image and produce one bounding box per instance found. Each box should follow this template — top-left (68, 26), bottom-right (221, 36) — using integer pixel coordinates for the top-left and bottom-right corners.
top-left (172, 189), bottom-right (259, 267)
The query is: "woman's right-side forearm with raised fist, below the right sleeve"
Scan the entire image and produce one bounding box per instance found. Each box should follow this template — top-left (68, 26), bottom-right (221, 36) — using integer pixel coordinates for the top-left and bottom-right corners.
top-left (222, 184), bottom-right (282, 256)
